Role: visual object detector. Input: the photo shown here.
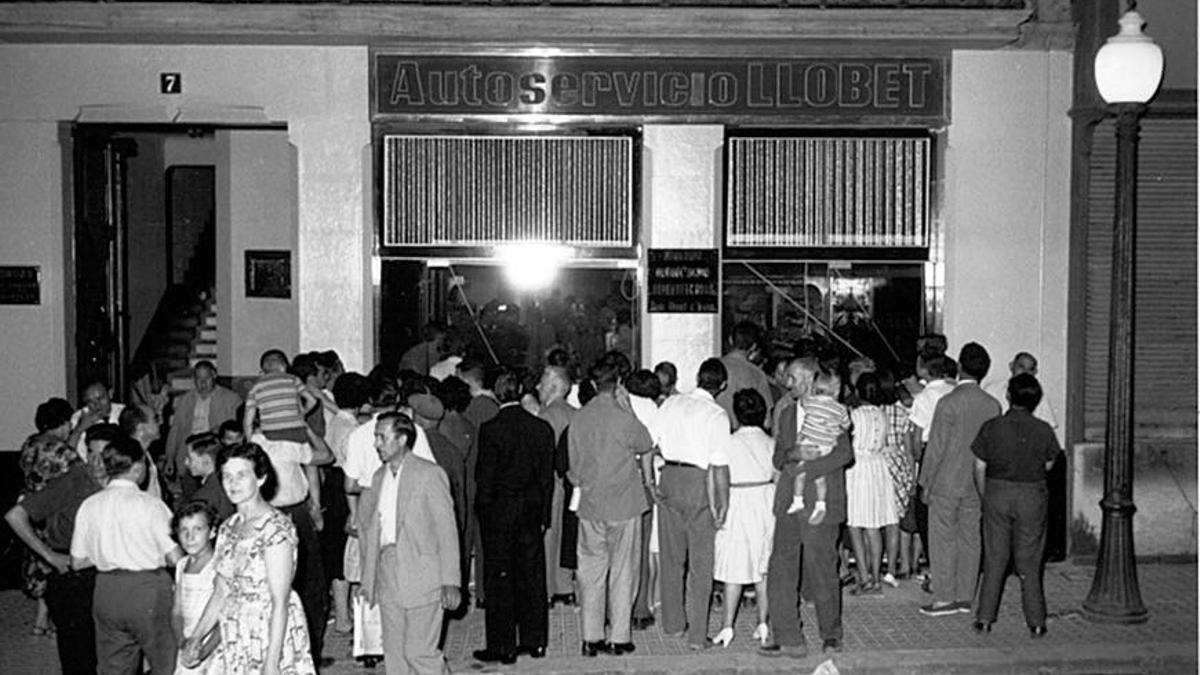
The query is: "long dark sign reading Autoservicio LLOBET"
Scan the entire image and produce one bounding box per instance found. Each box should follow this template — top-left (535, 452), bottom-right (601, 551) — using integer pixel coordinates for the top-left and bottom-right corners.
top-left (373, 53), bottom-right (947, 120)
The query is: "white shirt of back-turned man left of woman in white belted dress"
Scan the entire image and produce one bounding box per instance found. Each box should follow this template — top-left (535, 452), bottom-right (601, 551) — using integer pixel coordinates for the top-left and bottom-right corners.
top-left (653, 387), bottom-right (732, 468)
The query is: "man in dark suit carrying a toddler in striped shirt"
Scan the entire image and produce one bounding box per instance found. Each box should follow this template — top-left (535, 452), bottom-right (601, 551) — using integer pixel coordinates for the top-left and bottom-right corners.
top-left (762, 358), bottom-right (854, 658)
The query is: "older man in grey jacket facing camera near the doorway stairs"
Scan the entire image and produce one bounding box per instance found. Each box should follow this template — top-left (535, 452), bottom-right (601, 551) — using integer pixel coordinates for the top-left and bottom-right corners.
top-left (163, 360), bottom-right (241, 501)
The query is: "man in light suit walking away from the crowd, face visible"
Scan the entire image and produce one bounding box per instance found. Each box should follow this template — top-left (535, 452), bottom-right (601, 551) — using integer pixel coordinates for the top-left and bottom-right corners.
top-left (359, 412), bottom-right (461, 675)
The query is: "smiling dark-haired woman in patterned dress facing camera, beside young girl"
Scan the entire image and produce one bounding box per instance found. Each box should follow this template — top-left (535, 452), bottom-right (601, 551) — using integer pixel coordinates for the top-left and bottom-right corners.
top-left (184, 443), bottom-right (316, 675)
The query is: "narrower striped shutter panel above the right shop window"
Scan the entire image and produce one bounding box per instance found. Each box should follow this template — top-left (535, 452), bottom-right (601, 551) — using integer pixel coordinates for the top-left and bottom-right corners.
top-left (725, 136), bottom-right (931, 249)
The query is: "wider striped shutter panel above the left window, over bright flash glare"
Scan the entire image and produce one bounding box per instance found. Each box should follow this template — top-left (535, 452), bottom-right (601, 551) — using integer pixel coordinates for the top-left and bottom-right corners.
top-left (380, 135), bottom-right (635, 250)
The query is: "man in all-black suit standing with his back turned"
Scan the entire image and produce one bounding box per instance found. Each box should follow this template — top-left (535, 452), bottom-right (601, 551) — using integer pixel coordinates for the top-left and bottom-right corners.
top-left (474, 371), bottom-right (554, 664)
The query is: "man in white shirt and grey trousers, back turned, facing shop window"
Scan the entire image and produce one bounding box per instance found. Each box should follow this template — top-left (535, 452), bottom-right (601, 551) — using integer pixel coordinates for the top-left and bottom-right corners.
top-left (654, 358), bottom-right (731, 650)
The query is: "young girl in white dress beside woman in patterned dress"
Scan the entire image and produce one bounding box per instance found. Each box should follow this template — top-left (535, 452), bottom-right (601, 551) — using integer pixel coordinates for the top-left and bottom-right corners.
top-left (170, 502), bottom-right (217, 675)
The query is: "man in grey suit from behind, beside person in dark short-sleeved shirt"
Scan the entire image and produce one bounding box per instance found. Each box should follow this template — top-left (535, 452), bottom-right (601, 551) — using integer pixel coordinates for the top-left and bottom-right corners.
top-left (917, 342), bottom-right (1000, 616)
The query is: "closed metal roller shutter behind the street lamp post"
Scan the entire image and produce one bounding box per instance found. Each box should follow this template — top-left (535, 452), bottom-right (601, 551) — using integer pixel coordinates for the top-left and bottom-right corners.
top-left (1084, 118), bottom-right (1196, 441)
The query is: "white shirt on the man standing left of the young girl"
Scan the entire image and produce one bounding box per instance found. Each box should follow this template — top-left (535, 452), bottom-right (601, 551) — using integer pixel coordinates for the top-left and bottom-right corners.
top-left (71, 478), bottom-right (175, 572)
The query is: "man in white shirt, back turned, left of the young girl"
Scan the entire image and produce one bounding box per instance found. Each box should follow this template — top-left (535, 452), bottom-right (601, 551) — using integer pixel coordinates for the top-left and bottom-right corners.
top-left (71, 437), bottom-right (184, 675)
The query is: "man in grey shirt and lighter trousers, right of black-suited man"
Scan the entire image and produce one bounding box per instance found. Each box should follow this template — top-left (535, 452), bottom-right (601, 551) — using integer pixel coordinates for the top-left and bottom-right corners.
top-left (568, 362), bottom-right (654, 656)
